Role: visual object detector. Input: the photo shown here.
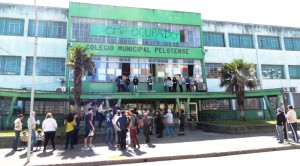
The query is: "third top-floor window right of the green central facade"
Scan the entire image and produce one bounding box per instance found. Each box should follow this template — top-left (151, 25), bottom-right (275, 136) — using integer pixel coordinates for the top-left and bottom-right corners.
top-left (257, 36), bottom-right (280, 50)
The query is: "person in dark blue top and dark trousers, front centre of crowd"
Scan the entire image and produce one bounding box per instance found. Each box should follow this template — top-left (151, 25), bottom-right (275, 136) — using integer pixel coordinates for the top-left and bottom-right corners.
top-left (116, 111), bottom-right (129, 150)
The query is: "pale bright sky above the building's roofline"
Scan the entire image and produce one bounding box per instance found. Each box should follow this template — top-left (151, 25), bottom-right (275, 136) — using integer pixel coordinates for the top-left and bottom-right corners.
top-left (0, 0), bottom-right (300, 28)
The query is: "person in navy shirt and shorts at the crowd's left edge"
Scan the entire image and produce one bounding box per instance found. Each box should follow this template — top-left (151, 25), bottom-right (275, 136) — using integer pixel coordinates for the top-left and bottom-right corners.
top-left (83, 108), bottom-right (95, 150)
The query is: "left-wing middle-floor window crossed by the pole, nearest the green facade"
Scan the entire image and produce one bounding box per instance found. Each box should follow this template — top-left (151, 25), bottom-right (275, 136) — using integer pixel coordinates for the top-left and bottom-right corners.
top-left (25, 57), bottom-right (65, 76)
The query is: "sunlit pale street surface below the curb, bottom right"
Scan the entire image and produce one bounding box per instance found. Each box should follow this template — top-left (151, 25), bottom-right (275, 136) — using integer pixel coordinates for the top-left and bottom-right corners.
top-left (120, 149), bottom-right (300, 166)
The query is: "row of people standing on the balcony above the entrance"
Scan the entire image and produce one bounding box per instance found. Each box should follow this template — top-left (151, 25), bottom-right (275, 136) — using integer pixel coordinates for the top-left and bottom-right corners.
top-left (115, 74), bottom-right (196, 92)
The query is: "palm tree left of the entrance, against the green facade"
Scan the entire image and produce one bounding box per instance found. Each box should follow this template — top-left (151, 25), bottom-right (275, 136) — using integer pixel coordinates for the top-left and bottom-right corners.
top-left (67, 45), bottom-right (94, 113)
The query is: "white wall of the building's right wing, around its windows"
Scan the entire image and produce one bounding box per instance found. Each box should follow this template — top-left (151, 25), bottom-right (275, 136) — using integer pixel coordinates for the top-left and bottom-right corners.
top-left (202, 20), bottom-right (300, 105)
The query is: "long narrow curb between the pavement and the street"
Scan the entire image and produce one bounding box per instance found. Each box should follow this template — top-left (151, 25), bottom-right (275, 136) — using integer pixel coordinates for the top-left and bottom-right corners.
top-left (37, 143), bottom-right (300, 166)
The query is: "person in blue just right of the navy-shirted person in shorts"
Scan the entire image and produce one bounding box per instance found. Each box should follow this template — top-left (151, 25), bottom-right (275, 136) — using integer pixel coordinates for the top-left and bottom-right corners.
top-left (106, 109), bottom-right (115, 146)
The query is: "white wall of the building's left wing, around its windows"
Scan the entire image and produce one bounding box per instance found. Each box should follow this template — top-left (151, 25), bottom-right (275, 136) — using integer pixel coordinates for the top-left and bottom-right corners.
top-left (0, 3), bottom-right (68, 91)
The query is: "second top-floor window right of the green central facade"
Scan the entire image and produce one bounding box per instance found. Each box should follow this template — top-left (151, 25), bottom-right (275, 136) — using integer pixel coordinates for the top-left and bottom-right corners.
top-left (229, 34), bottom-right (253, 48)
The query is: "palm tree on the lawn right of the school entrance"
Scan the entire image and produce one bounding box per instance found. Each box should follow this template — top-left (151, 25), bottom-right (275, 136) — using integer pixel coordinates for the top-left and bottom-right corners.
top-left (220, 59), bottom-right (260, 120)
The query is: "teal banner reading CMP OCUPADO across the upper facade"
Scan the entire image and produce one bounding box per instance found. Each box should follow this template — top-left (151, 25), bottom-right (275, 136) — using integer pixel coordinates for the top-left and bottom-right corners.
top-left (90, 24), bottom-right (180, 42)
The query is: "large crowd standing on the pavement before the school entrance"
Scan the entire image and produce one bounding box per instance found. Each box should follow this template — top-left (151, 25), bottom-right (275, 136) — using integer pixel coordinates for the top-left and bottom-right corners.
top-left (12, 102), bottom-right (185, 152)
